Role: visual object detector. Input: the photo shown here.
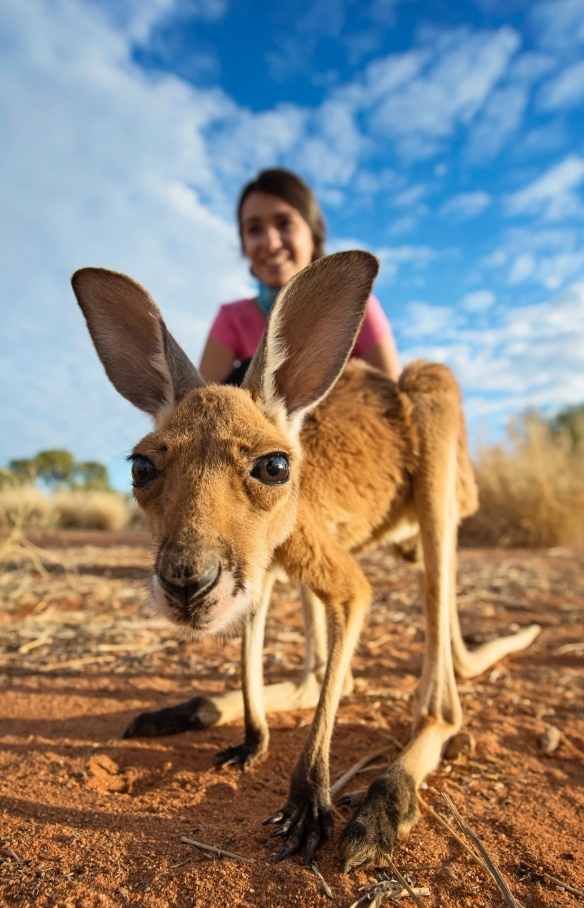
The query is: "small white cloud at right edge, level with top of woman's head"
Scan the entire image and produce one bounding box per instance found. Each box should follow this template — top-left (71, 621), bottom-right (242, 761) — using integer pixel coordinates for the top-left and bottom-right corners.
top-left (506, 155), bottom-right (584, 221)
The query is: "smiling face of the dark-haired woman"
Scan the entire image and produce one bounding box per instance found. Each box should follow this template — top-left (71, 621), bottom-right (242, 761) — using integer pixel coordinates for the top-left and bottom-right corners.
top-left (241, 192), bottom-right (314, 288)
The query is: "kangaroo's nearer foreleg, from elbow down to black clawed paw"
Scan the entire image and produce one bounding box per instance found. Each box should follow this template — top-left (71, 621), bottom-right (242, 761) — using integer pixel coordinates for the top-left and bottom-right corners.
top-left (266, 549), bottom-right (371, 863)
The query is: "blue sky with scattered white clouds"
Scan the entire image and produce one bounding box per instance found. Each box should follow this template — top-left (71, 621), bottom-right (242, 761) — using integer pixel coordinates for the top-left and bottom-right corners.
top-left (0, 0), bottom-right (584, 483)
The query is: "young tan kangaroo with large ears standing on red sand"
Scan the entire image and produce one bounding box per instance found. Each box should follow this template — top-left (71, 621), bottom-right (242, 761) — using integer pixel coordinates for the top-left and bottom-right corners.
top-left (72, 252), bottom-right (539, 870)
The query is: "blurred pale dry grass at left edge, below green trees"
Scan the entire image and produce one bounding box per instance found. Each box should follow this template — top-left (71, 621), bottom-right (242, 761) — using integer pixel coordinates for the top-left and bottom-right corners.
top-left (0, 486), bottom-right (139, 530)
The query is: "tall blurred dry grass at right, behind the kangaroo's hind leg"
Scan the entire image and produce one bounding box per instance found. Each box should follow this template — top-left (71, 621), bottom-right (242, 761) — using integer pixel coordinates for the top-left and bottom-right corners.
top-left (461, 416), bottom-right (584, 548)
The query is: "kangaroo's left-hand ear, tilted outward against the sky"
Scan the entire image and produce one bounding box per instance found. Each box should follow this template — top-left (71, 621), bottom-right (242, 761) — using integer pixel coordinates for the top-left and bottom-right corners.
top-left (71, 268), bottom-right (205, 423)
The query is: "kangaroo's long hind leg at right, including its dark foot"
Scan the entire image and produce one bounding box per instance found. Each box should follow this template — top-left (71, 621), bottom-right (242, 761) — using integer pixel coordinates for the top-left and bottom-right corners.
top-left (339, 370), bottom-right (462, 871)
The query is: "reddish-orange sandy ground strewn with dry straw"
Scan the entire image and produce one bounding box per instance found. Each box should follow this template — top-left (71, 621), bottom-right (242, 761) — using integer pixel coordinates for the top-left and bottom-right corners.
top-left (0, 533), bottom-right (584, 908)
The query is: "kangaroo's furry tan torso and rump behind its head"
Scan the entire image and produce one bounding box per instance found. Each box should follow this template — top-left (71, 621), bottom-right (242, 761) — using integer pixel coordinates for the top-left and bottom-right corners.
top-left (298, 361), bottom-right (477, 551)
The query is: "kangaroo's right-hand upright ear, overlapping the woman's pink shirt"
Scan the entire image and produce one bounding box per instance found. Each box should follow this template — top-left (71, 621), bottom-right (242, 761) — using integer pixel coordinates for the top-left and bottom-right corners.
top-left (243, 250), bottom-right (379, 425)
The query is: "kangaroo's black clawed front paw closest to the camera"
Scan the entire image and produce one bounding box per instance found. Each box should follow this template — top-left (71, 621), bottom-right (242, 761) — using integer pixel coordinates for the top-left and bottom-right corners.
top-left (264, 782), bottom-right (333, 864)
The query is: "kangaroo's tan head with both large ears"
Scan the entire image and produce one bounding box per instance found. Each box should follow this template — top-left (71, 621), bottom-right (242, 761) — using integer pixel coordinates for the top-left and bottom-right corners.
top-left (72, 251), bottom-right (378, 635)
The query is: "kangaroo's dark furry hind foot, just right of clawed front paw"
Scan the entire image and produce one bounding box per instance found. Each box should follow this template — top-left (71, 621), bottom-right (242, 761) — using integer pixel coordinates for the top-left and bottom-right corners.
top-left (339, 766), bottom-right (418, 873)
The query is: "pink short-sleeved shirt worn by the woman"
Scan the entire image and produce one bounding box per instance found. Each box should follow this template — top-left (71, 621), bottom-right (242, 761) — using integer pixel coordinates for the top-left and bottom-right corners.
top-left (209, 296), bottom-right (391, 362)
